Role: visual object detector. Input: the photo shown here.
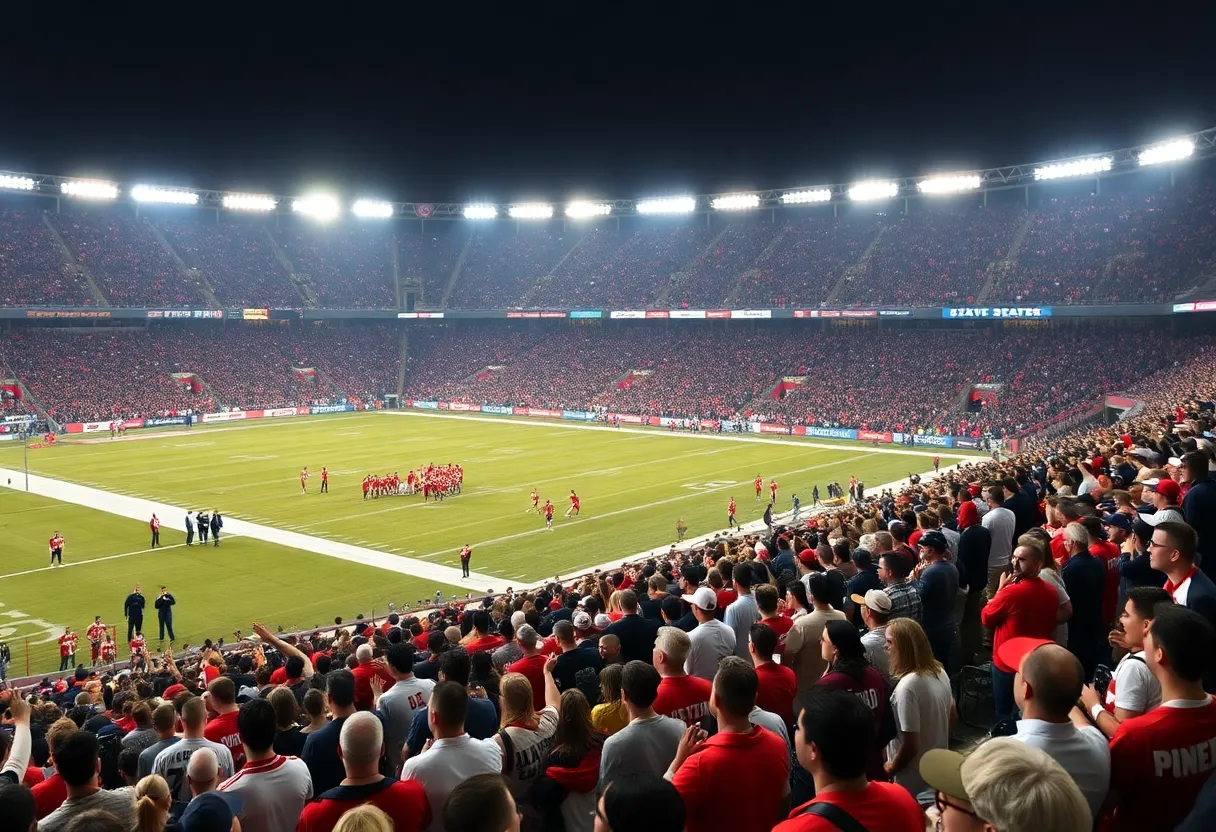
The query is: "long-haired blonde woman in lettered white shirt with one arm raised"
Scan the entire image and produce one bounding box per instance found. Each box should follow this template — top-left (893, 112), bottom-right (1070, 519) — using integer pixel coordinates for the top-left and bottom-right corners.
top-left (494, 656), bottom-right (561, 830)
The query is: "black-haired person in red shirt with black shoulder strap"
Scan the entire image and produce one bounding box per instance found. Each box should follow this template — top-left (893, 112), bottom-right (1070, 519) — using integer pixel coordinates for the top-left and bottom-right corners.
top-left (773, 687), bottom-right (924, 832)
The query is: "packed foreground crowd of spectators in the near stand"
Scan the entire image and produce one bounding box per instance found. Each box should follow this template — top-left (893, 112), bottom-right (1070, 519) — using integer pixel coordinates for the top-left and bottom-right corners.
top-left (7, 349), bottom-right (1216, 832)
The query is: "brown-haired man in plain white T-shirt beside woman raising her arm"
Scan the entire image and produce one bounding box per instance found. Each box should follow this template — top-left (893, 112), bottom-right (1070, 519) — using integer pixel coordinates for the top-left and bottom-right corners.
top-left (394, 681), bottom-right (502, 832)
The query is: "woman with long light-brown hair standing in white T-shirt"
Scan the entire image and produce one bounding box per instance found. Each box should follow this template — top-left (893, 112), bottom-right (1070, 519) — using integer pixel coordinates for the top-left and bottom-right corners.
top-left (885, 618), bottom-right (957, 806)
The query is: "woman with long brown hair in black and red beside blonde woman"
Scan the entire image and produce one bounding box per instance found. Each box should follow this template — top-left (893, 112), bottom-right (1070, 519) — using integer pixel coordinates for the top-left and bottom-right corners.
top-left (533, 690), bottom-right (604, 832)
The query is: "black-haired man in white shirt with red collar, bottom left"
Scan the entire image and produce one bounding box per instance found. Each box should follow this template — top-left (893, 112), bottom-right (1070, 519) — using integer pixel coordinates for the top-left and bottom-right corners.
top-left (216, 699), bottom-right (313, 832)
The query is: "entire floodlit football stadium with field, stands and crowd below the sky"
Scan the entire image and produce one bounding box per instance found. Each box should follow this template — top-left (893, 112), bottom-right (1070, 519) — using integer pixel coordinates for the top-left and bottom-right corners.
top-left (7, 43), bottom-right (1216, 832)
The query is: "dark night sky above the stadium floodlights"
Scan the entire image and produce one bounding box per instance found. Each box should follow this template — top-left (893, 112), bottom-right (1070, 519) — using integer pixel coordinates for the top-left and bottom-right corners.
top-left (0, 6), bottom-right (1216, 202)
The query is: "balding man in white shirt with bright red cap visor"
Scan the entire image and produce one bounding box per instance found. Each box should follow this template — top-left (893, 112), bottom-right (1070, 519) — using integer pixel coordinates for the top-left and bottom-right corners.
top-left (1001, 637), bottom-right (1110, 817)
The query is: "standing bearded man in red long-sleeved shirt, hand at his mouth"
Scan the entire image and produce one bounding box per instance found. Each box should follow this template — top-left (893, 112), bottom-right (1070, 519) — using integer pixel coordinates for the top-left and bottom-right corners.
top-left (980, 546), bottom-right (1059, 723)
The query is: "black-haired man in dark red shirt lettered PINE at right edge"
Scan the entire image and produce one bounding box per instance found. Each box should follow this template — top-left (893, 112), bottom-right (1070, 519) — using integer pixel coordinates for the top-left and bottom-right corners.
top-left (1108, 605), bottom-right (1216, 832)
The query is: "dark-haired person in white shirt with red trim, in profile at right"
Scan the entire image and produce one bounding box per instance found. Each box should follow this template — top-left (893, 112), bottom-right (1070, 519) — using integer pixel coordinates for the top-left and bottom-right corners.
top-left (1081, 586), bottom-right (1171, 738)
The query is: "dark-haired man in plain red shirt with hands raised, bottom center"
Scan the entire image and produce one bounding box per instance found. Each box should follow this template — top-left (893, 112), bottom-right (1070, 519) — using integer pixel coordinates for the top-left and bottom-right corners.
top-left (660, 656), bottom-right (789, 832)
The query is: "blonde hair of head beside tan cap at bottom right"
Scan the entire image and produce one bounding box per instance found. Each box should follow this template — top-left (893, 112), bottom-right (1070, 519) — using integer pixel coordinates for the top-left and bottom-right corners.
top-left (963, 739), bottom-right (1093, 832)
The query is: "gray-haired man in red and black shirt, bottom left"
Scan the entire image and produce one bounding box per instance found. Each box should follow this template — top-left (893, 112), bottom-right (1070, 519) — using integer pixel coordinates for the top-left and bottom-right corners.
top-left (295, 712), bottom-right (430, 832)
